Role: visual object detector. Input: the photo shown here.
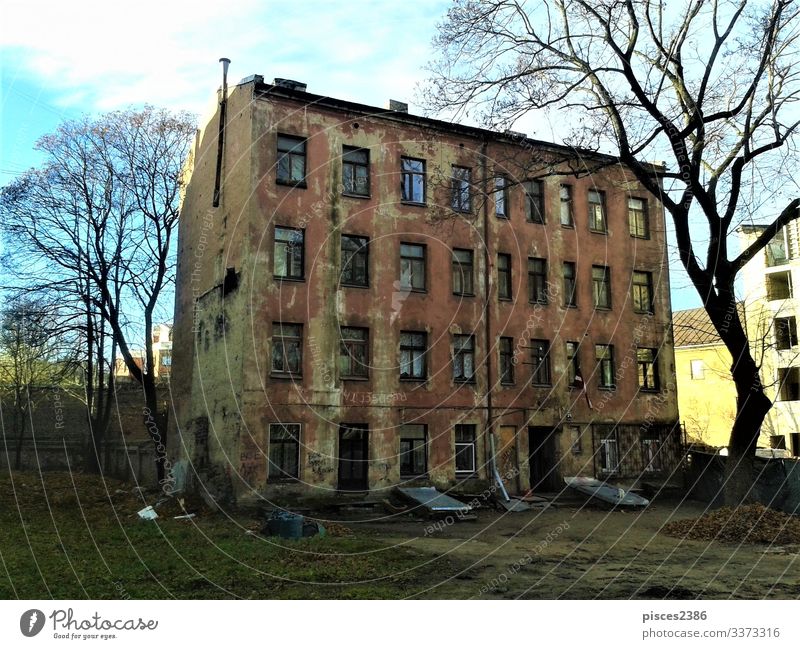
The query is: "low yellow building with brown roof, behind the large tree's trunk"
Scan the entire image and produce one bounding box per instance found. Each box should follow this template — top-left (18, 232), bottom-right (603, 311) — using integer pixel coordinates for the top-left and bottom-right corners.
top-left (673, 308), bottom-right (736, 446)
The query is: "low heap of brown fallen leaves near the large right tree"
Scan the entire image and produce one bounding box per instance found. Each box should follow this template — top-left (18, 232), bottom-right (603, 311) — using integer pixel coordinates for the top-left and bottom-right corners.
top-left (661, 504), bottom-right (800, 545)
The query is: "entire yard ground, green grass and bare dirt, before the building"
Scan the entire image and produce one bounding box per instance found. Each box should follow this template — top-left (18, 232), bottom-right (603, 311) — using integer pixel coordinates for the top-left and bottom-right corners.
top-left (0, 473), bottom-right (800, 599)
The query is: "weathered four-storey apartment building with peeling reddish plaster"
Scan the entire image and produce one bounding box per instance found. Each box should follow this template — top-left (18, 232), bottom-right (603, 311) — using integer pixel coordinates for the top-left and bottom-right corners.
top-left (173, 76), bottom-right (679, 499)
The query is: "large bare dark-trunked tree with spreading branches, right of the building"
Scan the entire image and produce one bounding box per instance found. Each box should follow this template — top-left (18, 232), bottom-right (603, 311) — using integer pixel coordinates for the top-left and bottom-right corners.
top-left (425, 0), bottom-right (800, 503)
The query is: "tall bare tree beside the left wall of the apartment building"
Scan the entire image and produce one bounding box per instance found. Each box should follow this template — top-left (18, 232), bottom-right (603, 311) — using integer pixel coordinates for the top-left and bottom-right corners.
top-left (0, 107), bottom-right (195, 481)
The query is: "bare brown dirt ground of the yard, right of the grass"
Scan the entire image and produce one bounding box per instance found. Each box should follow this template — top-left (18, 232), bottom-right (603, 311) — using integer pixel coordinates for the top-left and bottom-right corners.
top-left (348, 502), bottom-right (800, 599)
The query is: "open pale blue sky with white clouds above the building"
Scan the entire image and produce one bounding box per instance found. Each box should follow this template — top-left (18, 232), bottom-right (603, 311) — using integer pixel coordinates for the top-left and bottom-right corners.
top-left (0, 0), bottom-right (700, 309)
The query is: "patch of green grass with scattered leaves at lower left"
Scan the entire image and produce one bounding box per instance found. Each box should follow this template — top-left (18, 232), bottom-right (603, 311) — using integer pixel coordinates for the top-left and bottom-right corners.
top-left (0, 472), bottom-right (452, 599)
